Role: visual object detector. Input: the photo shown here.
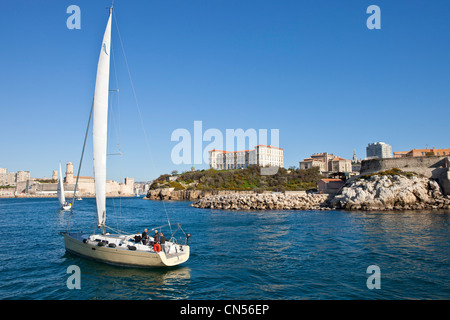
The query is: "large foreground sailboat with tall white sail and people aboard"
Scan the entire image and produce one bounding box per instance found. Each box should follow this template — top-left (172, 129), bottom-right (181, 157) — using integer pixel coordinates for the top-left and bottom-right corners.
top-left (62, 7), bottom-right (190, 268)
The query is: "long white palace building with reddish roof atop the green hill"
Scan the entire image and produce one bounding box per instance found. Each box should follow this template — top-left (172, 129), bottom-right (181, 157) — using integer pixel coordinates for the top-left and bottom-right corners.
top-left (209, 144), bottom-right (284, 170)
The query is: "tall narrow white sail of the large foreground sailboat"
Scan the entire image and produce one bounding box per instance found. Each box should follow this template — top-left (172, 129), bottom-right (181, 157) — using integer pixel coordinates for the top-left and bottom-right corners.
top-left (92, 8), bottom-right (112, 228)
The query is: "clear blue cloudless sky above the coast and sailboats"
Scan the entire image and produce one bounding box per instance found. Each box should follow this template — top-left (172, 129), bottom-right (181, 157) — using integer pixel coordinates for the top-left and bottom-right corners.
top-left (0, 0), bottom-right (450, 181)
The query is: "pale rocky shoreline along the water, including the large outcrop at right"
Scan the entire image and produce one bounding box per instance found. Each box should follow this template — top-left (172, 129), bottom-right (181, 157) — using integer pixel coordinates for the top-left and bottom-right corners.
top-left (147, 174), bottom-right (450, 211)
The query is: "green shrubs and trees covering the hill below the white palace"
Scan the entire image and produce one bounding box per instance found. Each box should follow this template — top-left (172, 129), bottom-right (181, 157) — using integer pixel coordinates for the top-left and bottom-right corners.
top-left (150, 166), bottom-right (325, 192)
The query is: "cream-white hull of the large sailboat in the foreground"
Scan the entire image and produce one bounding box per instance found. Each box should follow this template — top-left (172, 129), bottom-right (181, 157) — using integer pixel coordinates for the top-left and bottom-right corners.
top-left (64, 233), bottom-right (189, 268)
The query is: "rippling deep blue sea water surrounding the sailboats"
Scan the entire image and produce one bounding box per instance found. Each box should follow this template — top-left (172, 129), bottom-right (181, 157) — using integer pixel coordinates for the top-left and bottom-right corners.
top-left (0, 198), bottom-right (450, 300)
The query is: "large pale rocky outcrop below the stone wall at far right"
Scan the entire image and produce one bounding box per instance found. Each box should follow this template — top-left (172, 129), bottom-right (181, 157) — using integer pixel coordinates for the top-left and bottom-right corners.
top-left (330, 174), bottom-right (450, 210)
